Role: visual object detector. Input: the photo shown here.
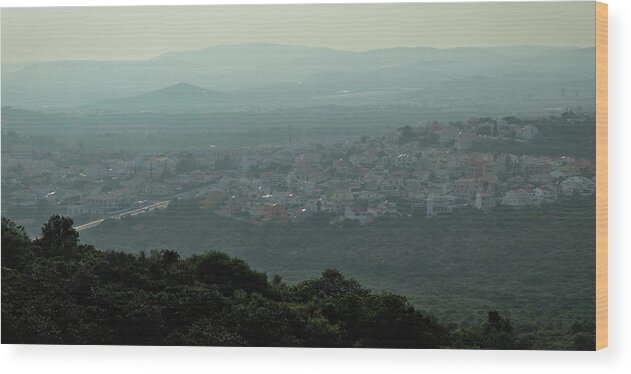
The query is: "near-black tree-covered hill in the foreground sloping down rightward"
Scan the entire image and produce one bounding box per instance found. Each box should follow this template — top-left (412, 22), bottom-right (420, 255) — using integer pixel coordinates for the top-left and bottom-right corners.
top-left (2, 216), bottom-right (552, 349)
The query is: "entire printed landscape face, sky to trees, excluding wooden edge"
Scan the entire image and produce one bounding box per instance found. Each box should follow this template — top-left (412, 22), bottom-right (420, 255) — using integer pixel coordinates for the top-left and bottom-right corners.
top-left (1, 3), bottom-right (596, 350)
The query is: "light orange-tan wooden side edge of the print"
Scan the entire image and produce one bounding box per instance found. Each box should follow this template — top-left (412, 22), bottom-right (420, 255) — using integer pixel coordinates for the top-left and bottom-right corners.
top-left (596, 2), bottom-right (608, 350)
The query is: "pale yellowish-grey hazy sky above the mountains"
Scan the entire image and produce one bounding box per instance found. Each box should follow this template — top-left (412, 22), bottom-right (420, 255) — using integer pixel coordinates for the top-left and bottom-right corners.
top-left (1, 2), bottom-right (594, 63)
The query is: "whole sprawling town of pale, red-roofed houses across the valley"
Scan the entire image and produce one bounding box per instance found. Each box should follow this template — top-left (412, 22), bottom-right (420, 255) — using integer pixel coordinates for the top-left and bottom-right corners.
top-left (2, 114), bottom-right (595, 229)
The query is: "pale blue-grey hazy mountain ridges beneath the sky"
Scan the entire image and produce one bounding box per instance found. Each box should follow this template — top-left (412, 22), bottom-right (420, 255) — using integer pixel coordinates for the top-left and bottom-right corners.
top-left (2, 43), bottom-right (595, 111)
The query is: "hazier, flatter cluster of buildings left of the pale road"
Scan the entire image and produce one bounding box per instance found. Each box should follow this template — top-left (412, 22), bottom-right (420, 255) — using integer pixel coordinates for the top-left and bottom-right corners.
top-left (2, 145), bottom-right (216, 217)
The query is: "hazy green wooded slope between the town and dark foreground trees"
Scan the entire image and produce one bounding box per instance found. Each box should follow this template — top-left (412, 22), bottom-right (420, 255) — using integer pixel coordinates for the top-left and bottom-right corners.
top-left (82, 196), bottom-right (596, 349)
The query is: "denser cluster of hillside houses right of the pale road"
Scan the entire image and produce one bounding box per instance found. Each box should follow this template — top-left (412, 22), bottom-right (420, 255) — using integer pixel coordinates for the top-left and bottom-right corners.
top-left (188, 117), bottom-right (595, 224)
